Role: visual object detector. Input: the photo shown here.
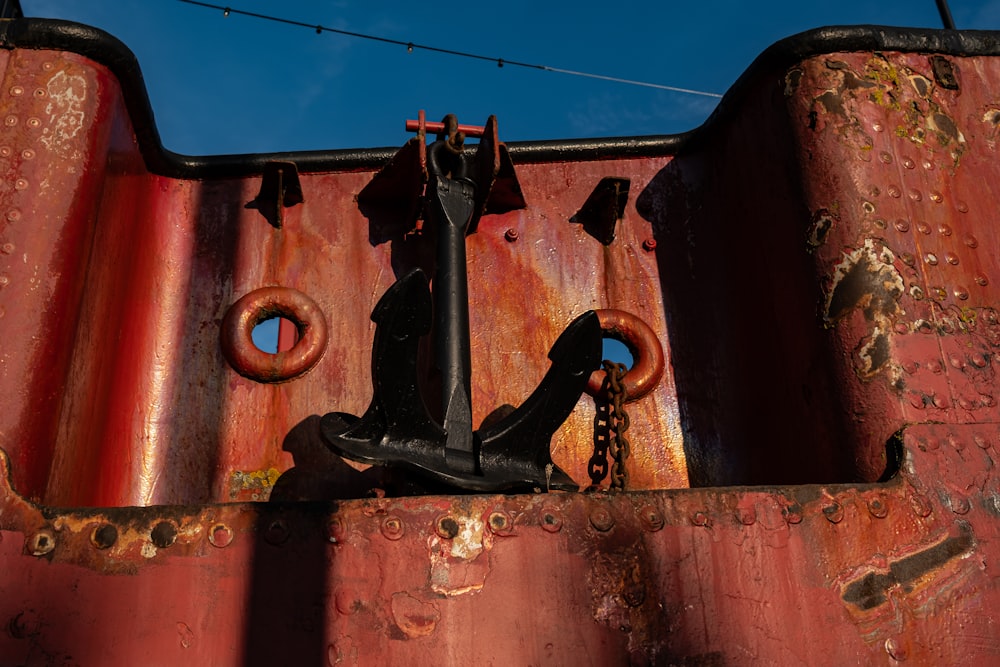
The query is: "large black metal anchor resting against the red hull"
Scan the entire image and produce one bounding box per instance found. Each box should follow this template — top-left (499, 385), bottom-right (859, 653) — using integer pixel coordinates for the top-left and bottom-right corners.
top-left (321, 117), bottom-right (603, 492)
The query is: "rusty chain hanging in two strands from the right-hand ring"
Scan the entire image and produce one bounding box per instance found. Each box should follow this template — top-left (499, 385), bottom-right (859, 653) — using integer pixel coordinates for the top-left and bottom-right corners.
top-left (588, 360), bottom-right (632, 491)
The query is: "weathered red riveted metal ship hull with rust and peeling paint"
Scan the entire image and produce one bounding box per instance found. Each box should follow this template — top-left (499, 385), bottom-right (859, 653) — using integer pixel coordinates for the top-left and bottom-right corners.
top-left (0, 21), bottom-right (1000, 665)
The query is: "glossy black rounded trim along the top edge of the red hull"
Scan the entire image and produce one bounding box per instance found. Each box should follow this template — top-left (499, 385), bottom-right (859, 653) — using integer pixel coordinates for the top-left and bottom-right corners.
top-left (0, 18), bottom-right (1000, 179)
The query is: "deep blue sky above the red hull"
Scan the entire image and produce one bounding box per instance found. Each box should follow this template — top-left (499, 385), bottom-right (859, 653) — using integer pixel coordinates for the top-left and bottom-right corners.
top-left (22, 0), bottom-right (1000, 155)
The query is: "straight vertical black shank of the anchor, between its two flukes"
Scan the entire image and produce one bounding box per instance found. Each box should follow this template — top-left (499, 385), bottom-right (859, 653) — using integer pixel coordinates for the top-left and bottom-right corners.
top-left (431, 178), bottom-right (478, 473)
